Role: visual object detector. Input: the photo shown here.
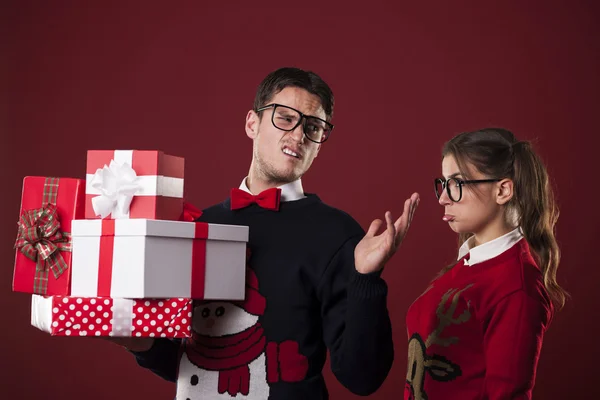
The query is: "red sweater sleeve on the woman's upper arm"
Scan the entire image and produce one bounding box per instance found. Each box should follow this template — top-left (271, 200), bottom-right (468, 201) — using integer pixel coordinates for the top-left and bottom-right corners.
top-left (484, 290), bottom-right (550, 400)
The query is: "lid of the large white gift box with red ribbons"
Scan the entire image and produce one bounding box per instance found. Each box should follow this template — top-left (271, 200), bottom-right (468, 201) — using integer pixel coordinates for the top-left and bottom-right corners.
top-left (71, 219), bottom-right (249, 242)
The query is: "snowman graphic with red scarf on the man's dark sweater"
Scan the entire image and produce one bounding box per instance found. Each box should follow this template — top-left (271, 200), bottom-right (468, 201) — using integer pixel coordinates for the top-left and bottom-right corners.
top-left (176, 268), bottom-right (308, 400)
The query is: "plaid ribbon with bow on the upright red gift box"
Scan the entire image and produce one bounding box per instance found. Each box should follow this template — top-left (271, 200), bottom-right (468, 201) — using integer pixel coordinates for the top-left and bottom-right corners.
top-left (15, 178), bottom-right (71, 295)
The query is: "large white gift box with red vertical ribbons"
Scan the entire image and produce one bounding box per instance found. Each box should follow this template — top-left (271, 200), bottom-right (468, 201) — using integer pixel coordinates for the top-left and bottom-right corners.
top-left (71, 219), bottom-right (249, 300)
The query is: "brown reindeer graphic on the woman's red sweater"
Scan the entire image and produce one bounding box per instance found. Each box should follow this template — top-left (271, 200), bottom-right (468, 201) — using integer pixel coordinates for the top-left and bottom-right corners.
top-left (405, 284), bottom-right (473, 400)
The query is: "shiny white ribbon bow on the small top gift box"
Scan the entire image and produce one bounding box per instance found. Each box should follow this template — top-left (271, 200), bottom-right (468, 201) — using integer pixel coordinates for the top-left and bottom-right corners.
top-left (90, 160), bottom-right (142, 219)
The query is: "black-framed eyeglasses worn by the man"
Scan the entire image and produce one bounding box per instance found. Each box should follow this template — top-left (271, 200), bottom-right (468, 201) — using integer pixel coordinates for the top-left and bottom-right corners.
top-left (256, 103), bottom-right (333, 143)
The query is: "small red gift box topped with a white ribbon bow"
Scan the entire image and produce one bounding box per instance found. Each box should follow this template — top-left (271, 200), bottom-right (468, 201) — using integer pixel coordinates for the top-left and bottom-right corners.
top-left (85, 150), bottom-right (184, 220)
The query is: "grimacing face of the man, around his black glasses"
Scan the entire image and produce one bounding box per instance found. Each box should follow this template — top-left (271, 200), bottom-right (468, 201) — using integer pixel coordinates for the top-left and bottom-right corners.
top-left (246, 87), bottom-right (326, 184)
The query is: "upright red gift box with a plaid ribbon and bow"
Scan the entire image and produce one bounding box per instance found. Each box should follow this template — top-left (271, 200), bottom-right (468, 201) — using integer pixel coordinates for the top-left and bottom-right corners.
top-left (12, 176), bottom-right (85, 295)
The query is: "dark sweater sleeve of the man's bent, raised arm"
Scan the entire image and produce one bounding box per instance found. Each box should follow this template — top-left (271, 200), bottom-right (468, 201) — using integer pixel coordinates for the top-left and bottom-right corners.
top-left (317, 237), bottom-right (394, 395)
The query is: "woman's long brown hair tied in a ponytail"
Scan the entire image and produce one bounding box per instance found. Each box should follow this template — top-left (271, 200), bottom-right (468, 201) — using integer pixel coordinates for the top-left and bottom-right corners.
top-left (442, 128), bottom-right (568, 308)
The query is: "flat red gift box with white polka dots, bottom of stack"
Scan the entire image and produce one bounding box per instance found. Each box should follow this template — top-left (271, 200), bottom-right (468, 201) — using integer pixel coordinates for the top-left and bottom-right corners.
top-left (31, 295), bottom-right (192, 338)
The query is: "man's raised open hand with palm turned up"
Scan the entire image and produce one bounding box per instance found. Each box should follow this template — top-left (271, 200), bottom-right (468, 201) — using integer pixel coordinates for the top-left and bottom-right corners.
top-left (354, 193), bottom-right (419, 274)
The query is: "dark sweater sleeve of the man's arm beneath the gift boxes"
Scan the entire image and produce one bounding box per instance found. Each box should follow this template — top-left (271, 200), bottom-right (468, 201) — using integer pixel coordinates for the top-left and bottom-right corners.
top-left (130, 339), bottom-right (181, 382)
